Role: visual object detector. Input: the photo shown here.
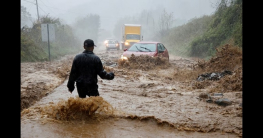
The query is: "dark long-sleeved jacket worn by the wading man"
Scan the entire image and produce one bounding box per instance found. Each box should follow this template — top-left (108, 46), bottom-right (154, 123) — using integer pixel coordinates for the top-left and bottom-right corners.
top-left (67, 50), bottom-right (111, 91)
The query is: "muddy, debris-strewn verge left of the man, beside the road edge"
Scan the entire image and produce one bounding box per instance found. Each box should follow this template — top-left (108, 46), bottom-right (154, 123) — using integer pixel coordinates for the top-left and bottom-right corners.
top-left (20, 56), bottom-right (74, 111)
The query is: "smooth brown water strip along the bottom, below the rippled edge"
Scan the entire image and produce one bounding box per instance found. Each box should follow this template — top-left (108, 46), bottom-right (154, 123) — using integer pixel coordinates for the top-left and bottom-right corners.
top-left (21, 115), bottom-right (234, 138)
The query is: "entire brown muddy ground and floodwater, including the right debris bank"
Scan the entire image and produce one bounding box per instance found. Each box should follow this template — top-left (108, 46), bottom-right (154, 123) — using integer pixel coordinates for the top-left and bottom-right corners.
top-left (21, 45), bottom-right (242, 137)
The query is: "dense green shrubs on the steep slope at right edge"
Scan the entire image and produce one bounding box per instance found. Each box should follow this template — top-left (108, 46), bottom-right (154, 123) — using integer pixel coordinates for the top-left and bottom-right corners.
top-left (189, 0), bottom-right (242, 58)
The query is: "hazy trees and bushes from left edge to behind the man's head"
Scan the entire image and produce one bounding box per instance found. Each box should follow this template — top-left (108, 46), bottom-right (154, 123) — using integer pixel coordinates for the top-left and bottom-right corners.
top-left (21, 6), bottom-right (100, 62)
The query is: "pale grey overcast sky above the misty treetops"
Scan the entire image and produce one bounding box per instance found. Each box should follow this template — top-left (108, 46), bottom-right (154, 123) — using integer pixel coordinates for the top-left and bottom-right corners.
top-left (21, 0), bottom-right (218, 30)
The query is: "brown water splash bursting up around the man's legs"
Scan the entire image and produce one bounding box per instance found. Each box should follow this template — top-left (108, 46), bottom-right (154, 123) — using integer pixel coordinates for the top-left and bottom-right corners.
top-left (40, 96), bottom-right (114, 120)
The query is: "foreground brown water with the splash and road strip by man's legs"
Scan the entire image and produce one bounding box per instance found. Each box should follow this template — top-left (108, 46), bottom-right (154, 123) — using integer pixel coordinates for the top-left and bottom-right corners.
top-left (21, 81), bottom-right (237, 138)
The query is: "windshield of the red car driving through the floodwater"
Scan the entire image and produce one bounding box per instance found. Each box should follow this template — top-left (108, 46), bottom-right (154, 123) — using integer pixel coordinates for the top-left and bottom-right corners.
top-left (127, 43), bottom-right (156, 52)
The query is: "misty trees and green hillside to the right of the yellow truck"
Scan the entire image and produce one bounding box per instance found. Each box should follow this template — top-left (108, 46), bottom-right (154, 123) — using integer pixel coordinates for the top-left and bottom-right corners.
top-left (114, 0), bottom-right (242, 60)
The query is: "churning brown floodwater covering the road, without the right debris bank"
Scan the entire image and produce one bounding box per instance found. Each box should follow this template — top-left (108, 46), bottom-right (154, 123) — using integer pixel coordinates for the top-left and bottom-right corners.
top-left (21, 44), bottom-right (242, 138)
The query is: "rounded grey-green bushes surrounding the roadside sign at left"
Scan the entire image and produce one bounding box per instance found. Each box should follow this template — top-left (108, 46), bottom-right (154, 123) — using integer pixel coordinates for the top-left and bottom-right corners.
top-left (21, 16), bottom-right (81, 62)
